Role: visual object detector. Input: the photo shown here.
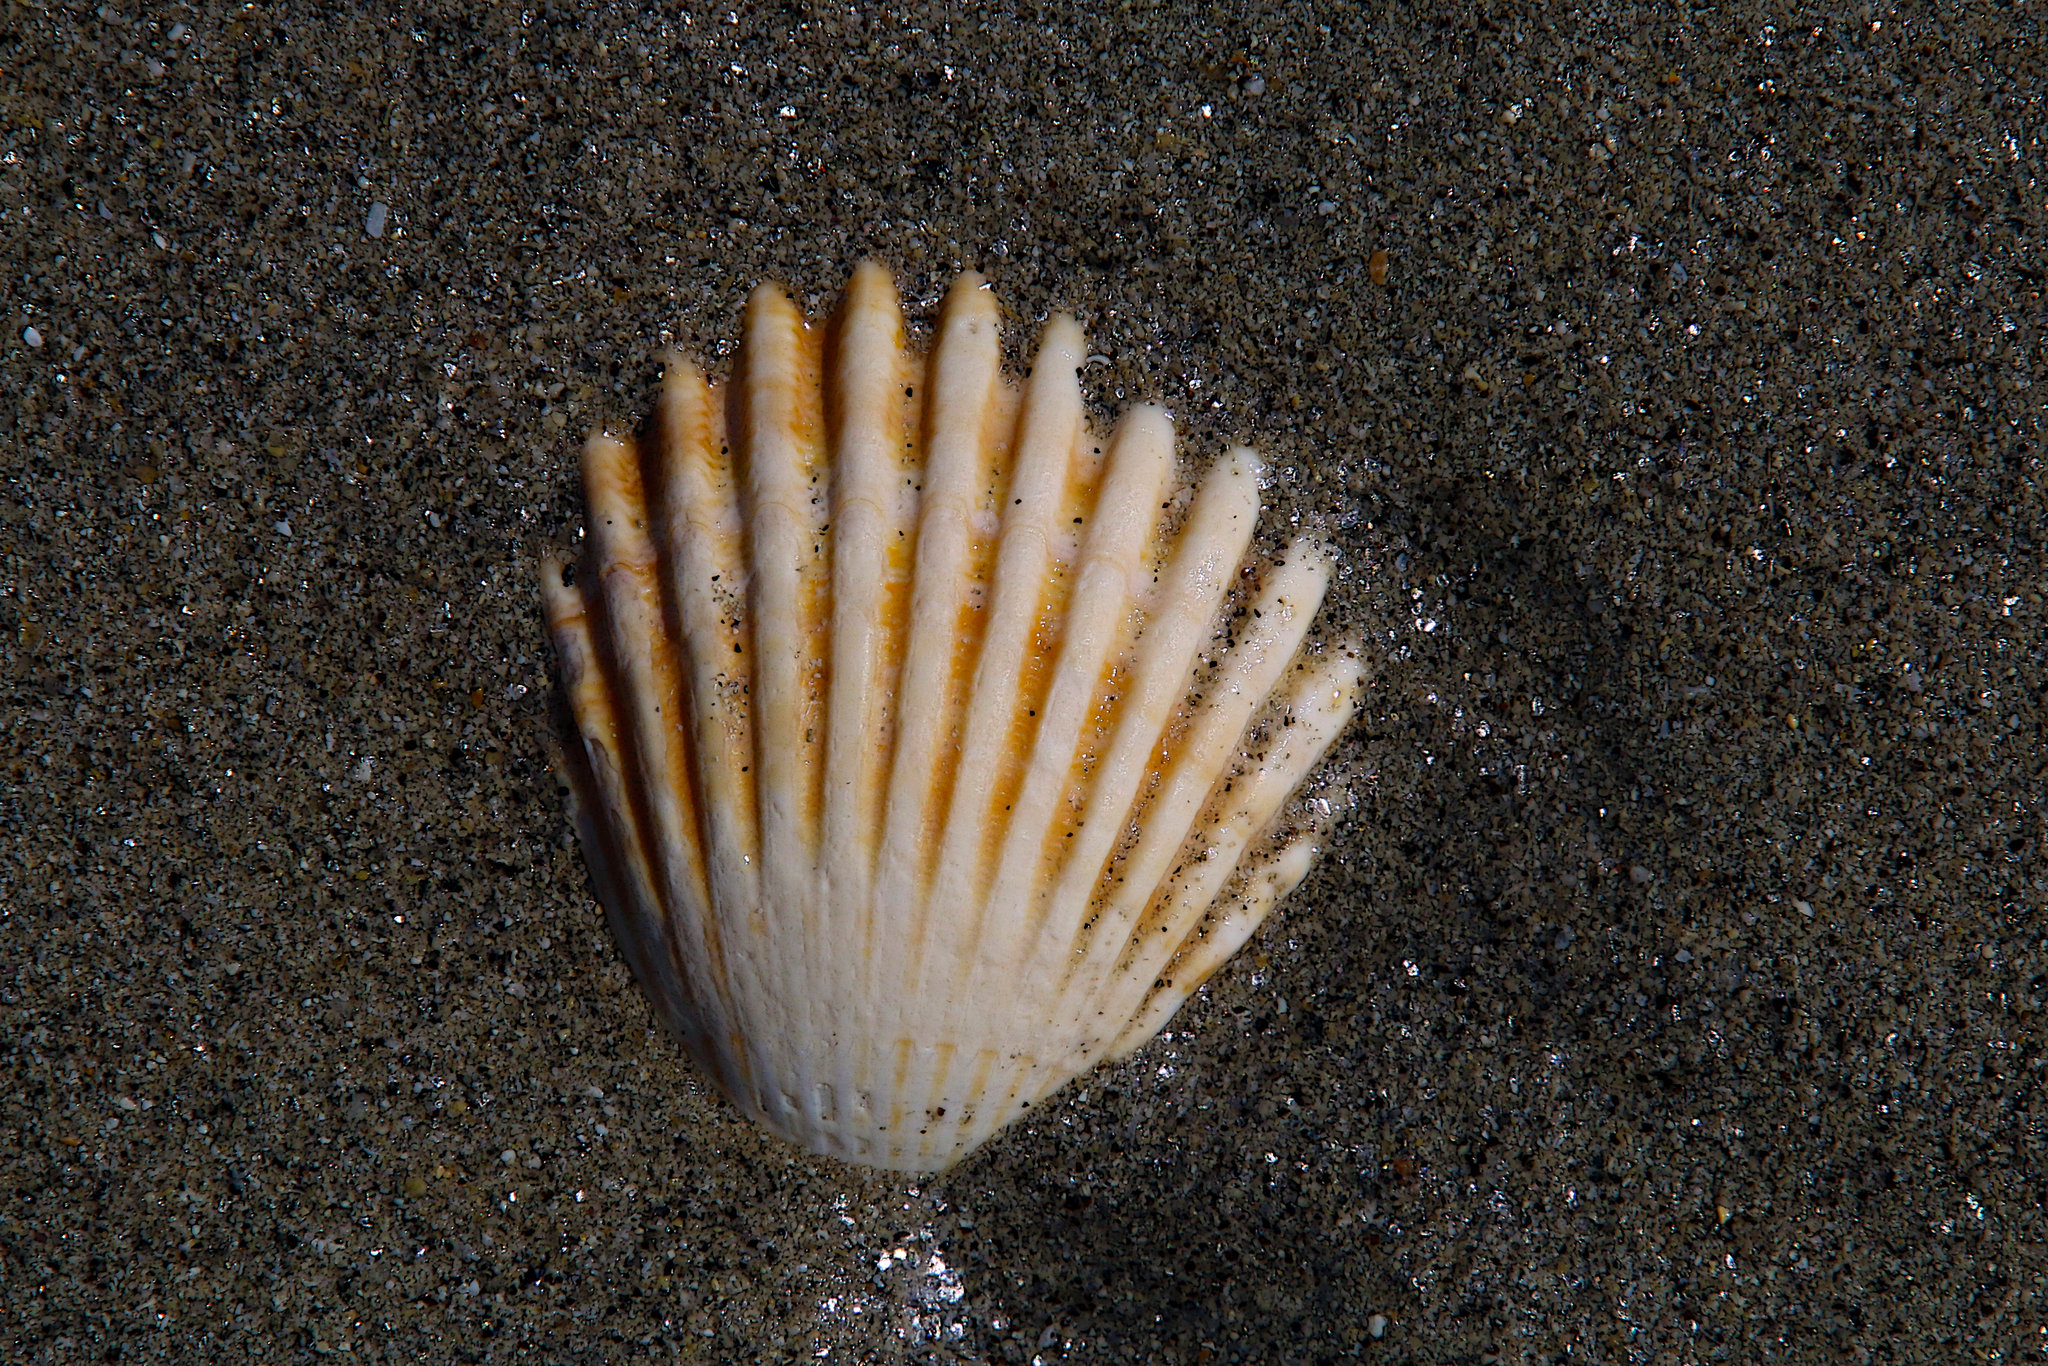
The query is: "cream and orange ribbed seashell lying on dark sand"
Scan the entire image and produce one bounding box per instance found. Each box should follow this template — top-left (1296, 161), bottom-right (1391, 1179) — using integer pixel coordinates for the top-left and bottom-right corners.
top-left (543, 262), bottom-right (1360, 1171)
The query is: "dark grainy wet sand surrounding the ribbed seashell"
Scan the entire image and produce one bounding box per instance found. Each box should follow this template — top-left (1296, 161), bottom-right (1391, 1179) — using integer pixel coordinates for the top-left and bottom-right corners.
top-left (0, 0), bottom-right (2048, 1364)
